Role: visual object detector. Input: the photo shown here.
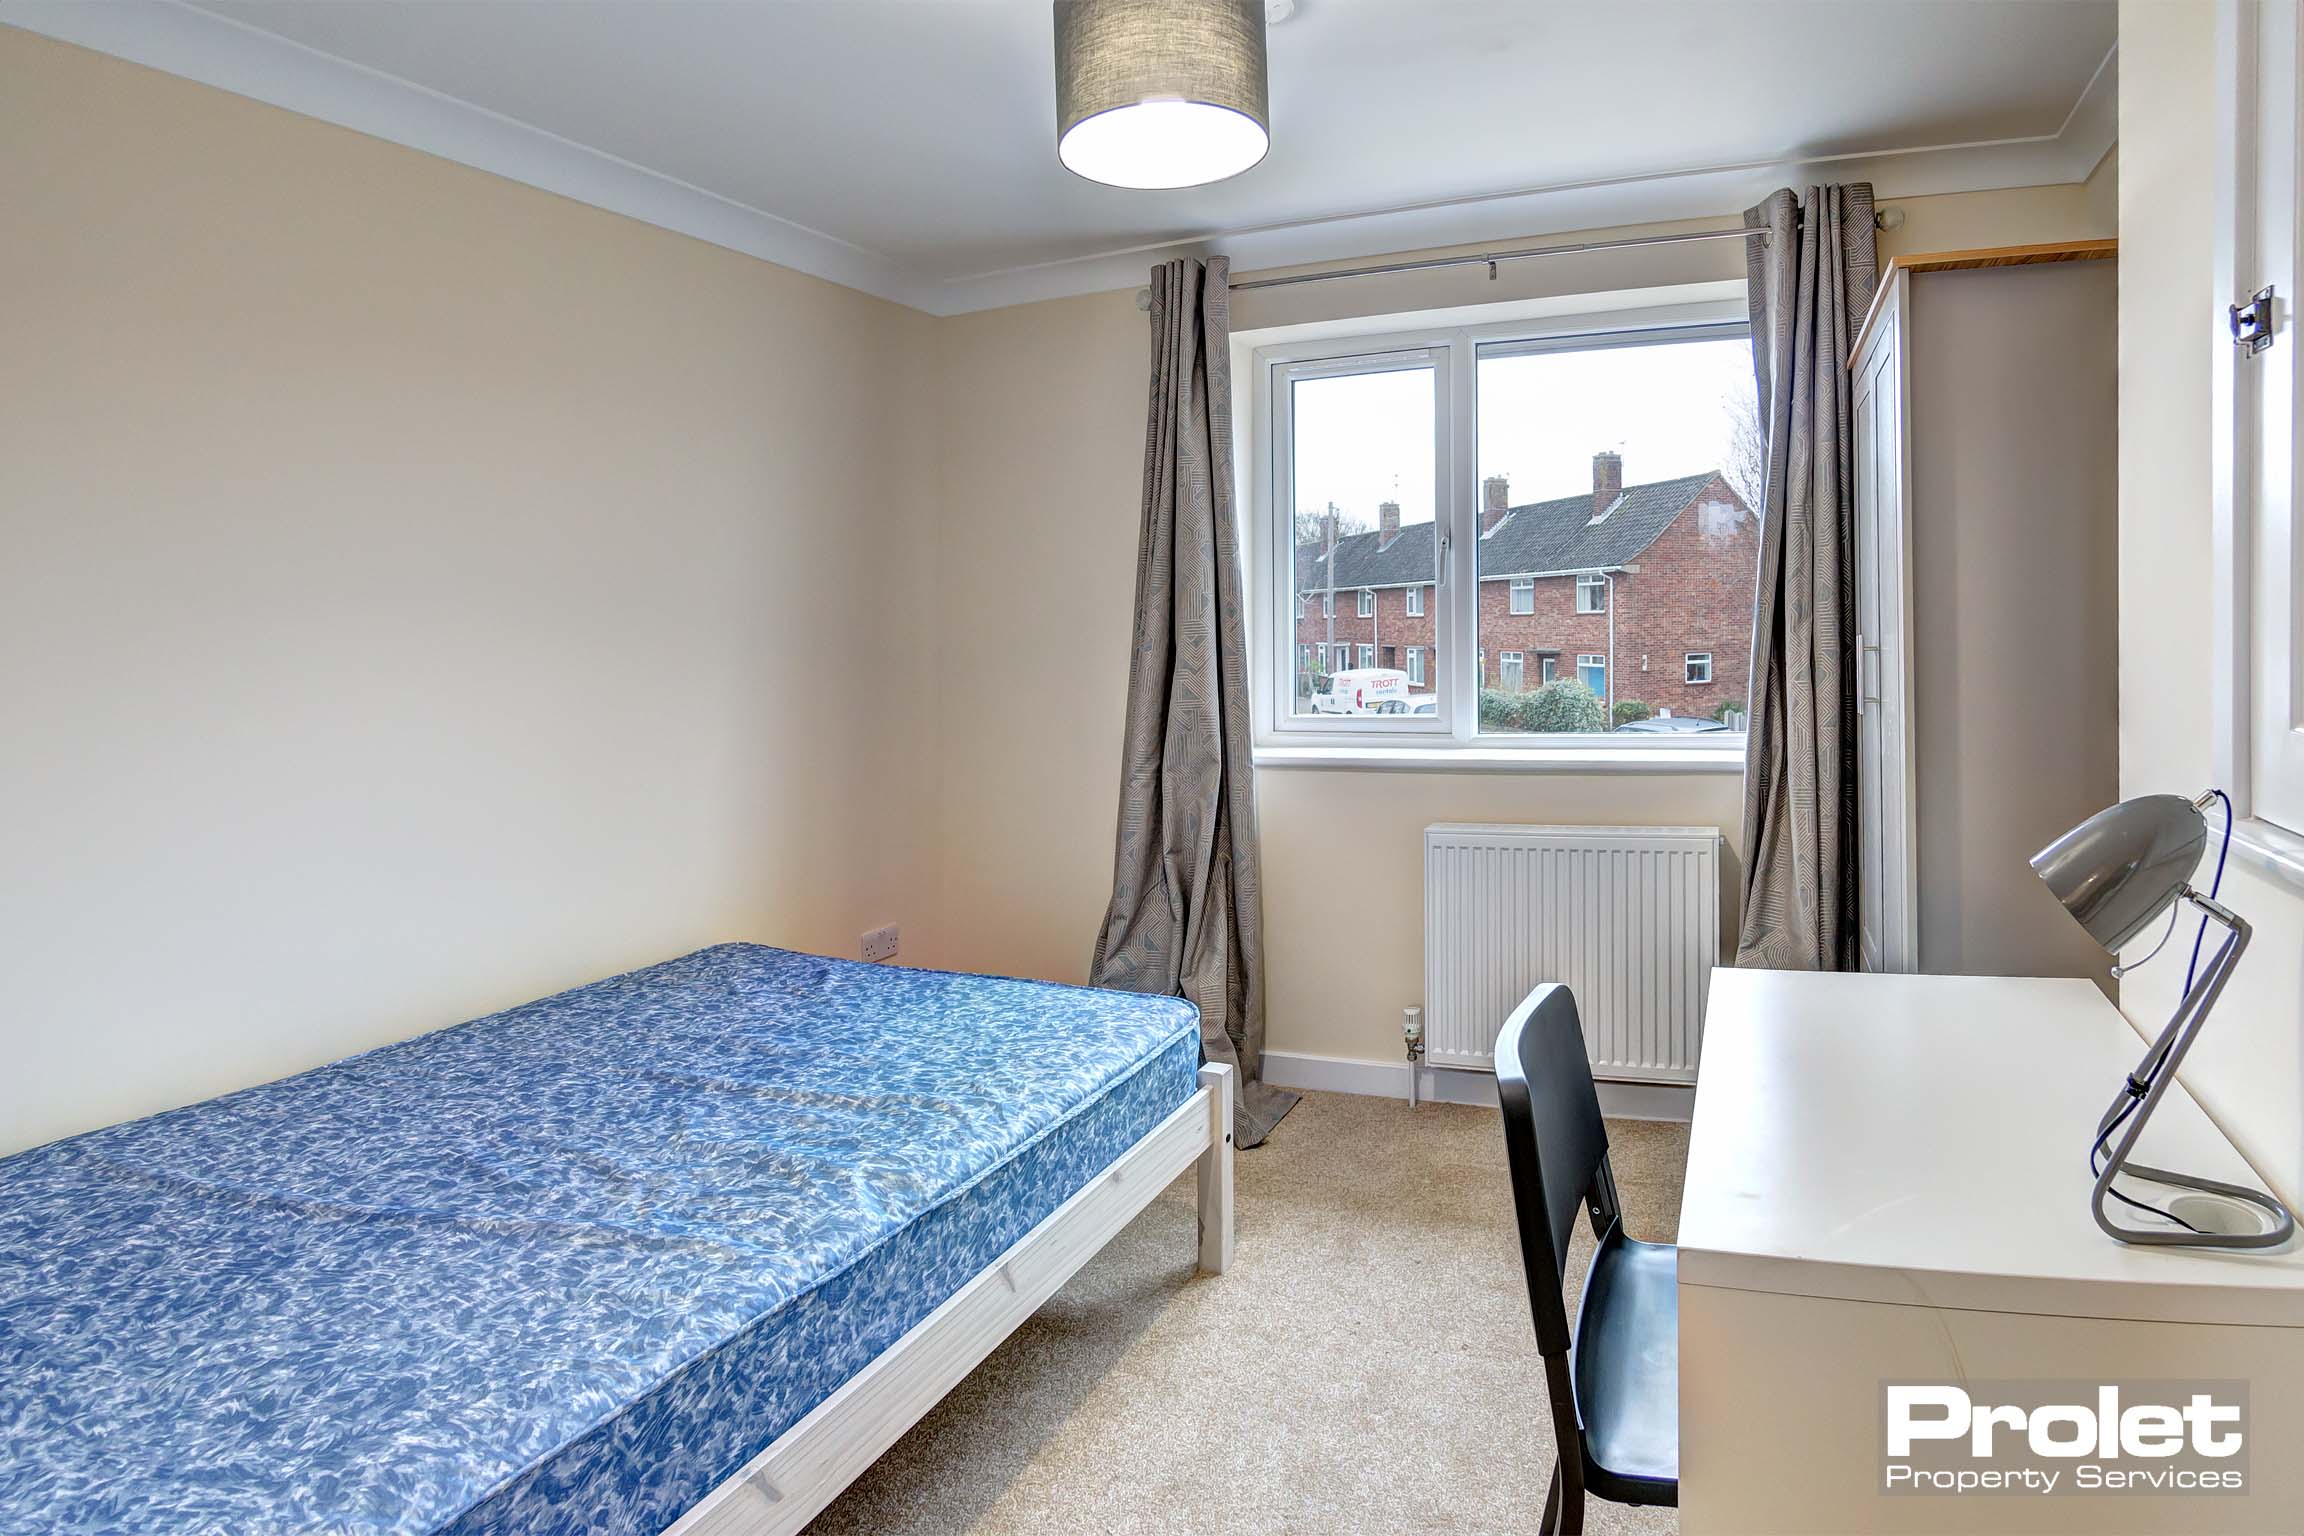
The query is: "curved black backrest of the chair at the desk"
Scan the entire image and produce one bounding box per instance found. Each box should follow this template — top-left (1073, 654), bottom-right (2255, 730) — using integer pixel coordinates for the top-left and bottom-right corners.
top-left (1495, 983), bottom-right (1615, 1354)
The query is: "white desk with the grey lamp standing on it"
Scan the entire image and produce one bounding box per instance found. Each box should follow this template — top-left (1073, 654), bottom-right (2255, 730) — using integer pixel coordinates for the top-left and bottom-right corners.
top-left (1680, 969), bottom-right (2304, 1536)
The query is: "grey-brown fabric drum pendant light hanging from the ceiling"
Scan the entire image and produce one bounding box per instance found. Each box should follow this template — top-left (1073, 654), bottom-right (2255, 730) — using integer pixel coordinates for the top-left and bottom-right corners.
top-left (1055, 0), bottom-right (1272, 187)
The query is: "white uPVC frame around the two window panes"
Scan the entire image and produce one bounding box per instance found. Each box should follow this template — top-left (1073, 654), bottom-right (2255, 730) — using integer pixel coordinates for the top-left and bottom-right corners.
top-left (1235, 297), bottom-right (1749, 774)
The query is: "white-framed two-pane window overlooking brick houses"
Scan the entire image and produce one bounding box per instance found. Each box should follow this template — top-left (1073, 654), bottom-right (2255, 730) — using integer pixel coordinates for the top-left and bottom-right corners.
top-left (1242, 313), bottom-right (1758, 762)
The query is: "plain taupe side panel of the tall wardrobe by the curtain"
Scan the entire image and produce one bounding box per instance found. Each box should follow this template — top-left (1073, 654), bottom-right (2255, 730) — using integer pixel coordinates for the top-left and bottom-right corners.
top-left (1898, 263), bottom-right (2120, 988)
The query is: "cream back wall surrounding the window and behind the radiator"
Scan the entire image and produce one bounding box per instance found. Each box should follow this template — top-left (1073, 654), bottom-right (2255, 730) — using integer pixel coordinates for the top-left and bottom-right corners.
top-left (926, 187), bottom-right (2110, 1059)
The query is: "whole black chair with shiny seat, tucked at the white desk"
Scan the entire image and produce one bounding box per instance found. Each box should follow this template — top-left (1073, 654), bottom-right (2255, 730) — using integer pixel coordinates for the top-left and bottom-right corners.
top-left (1495, 983), bottom-right (1680, 1536)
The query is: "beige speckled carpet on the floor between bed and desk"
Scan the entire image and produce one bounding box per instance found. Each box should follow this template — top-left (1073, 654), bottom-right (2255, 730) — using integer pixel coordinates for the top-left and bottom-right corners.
top-left (809, 1094), bottom-right (1687, 1536)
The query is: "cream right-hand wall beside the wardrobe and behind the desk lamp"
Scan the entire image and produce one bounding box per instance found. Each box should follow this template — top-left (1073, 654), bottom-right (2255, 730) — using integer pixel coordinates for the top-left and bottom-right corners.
top-left (2120, 0), bottom-right (2304, 1200)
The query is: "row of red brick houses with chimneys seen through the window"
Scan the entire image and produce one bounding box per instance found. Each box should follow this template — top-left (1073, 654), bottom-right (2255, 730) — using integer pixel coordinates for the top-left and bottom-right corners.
top-left (1297, 454), bottom-right (1760, 716)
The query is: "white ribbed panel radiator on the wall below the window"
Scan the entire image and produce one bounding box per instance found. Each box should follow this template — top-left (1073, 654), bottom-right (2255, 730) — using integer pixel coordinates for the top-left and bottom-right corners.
top-left (1424, 827), bottom-right (1721, 1082)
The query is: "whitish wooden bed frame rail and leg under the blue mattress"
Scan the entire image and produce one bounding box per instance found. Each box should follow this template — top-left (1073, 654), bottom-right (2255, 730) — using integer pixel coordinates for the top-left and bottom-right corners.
top-left (664, 1066), bottom-right (1233, 1536)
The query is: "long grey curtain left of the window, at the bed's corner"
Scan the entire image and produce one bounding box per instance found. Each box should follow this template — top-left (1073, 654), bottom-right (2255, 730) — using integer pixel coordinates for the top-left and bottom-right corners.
top-left (1087, 256), bottom-right (1297, 1147)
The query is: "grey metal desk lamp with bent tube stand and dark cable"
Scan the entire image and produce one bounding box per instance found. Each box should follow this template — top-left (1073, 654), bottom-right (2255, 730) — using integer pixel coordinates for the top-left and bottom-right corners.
top-left (2032, 790), bottom-right (2297, 1248)
